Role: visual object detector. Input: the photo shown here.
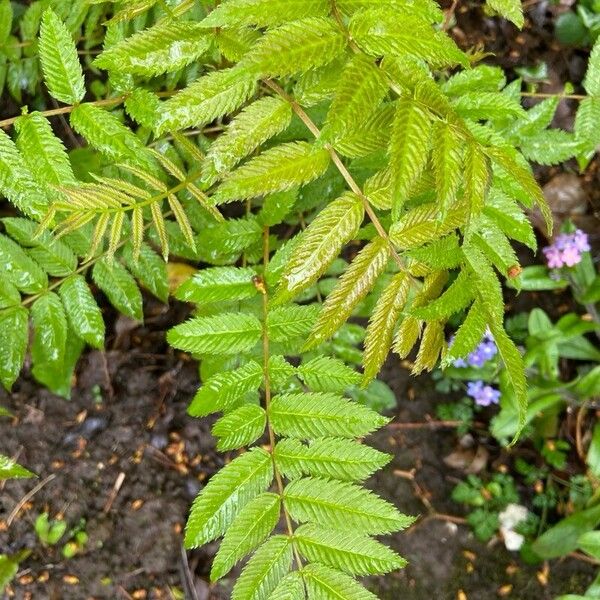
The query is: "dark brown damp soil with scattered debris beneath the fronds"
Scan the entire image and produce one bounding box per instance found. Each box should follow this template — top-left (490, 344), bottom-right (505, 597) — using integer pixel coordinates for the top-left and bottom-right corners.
top-left (0, 307), bottom-right (592, 600)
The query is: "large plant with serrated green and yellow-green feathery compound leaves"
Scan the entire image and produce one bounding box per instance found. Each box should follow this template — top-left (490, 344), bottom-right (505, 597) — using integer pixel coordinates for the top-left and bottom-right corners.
top-left (0, 0), bottom-right (600, 600)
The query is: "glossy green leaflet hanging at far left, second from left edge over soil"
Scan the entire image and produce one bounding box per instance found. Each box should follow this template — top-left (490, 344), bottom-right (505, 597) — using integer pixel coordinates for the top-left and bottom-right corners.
top-left (31, 292), bottom-right (67, 374)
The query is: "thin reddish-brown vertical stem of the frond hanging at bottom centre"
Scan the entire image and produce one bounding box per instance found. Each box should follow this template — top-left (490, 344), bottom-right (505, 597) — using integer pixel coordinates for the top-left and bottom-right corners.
top-left (255, 227), bottom-right (302, 569)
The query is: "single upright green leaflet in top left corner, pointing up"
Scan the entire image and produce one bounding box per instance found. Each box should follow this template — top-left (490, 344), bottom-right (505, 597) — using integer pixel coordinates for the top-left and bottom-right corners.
top-left (39, 8), bottom-right (85, 104)
